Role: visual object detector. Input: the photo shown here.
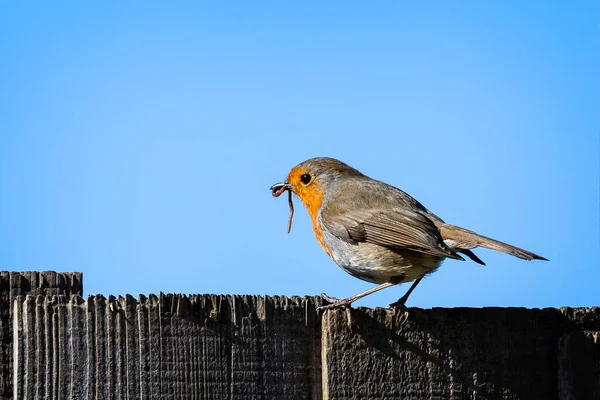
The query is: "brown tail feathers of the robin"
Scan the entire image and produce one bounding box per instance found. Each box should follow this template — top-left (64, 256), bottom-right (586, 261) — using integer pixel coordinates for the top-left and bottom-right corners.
top-left (439, 224), bottom-right (548, 264)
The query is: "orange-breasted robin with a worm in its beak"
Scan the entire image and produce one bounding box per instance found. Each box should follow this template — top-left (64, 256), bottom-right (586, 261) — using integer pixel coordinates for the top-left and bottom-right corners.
top-left (271, 157), bottom-right (547, 309)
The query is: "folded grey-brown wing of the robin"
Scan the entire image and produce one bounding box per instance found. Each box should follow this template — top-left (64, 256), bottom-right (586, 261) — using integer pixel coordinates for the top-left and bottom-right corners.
top-left (322, 208), bottom-right (463, 260)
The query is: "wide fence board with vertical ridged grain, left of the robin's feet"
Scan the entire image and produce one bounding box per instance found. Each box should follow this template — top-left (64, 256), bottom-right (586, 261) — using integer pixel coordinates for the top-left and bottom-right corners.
top-left (13, 294), bottom-right (321, 399)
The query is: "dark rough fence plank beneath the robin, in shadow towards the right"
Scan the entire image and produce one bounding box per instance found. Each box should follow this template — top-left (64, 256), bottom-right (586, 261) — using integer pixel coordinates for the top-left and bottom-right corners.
top-left (322, 308), bottom-right (600, 399)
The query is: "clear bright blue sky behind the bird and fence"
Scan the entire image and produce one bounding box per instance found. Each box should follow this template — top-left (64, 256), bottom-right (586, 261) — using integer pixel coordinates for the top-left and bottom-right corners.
top-left (0, 1), bottom-right (600, 307)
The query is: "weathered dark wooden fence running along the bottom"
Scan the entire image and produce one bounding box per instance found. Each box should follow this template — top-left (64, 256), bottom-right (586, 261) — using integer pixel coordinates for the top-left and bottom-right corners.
top-left (0, 272), bottom-right (600, 400)
